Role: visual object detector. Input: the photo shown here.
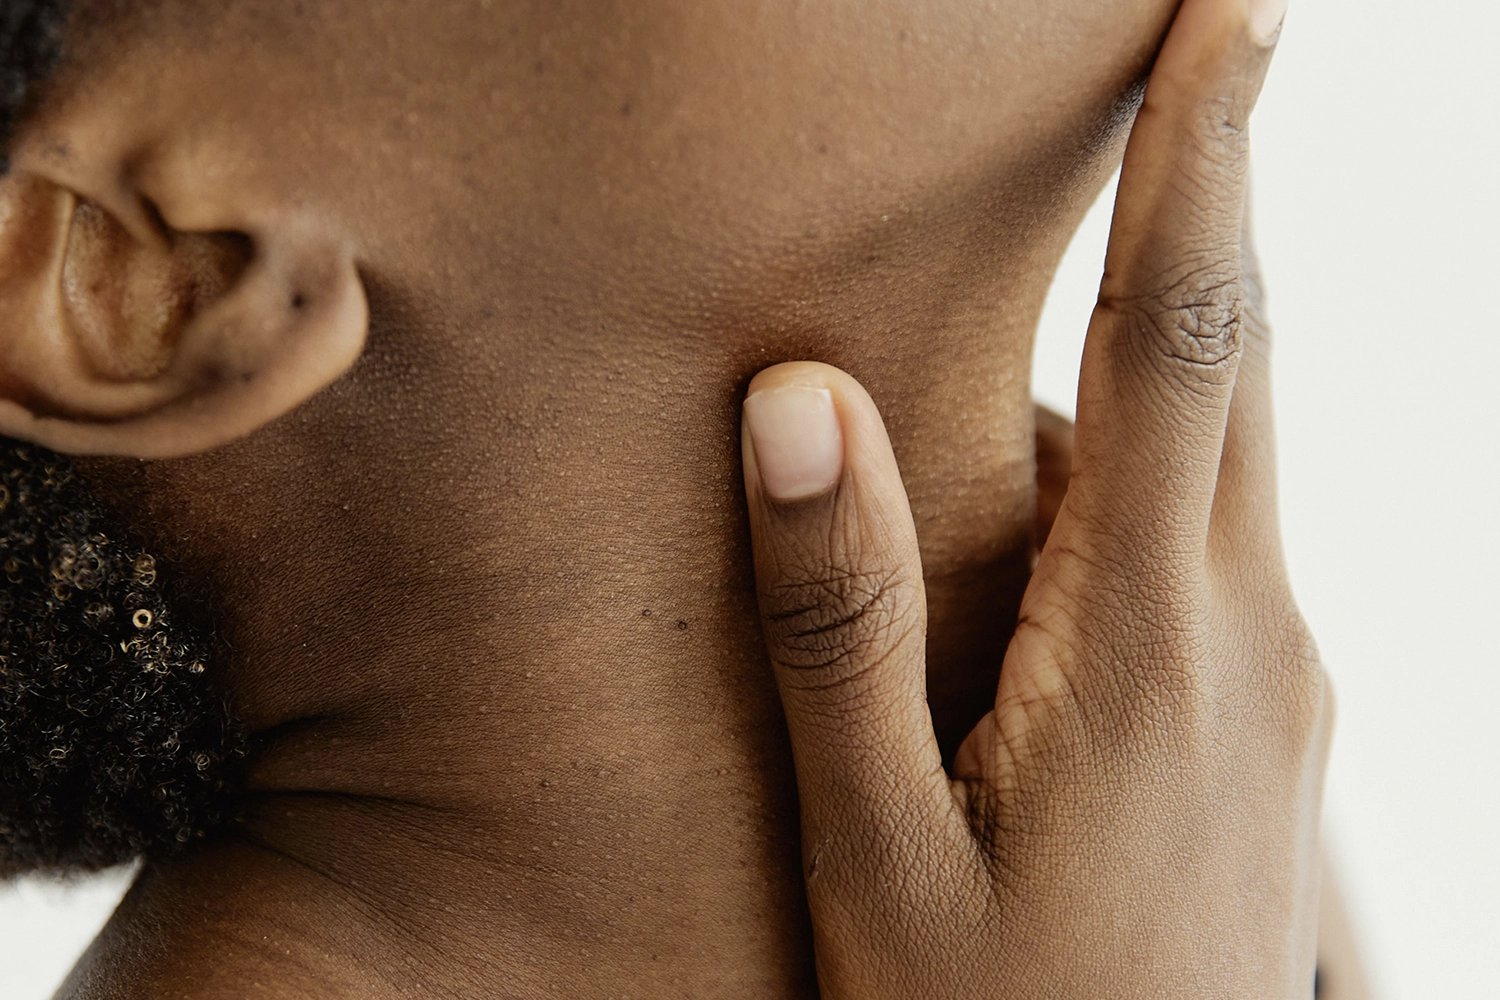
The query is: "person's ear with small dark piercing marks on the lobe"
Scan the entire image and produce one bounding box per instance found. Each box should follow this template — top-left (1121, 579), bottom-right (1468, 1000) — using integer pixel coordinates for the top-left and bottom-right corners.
top-left (0, 159), bottom-right (368, 459)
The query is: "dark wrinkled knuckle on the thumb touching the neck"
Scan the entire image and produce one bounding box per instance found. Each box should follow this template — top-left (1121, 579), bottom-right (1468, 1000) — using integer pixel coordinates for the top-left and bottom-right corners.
top-left (761, 570), bottom-right (911, 687)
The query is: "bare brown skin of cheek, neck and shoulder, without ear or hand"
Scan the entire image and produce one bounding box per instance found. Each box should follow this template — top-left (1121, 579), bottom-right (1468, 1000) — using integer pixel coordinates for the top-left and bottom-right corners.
top-left (6, 0), bottom-right (1260, 997)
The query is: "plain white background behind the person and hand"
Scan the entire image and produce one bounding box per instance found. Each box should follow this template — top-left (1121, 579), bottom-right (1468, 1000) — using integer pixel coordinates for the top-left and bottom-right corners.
top-left (0, 0), bottom-right (1500, 1000)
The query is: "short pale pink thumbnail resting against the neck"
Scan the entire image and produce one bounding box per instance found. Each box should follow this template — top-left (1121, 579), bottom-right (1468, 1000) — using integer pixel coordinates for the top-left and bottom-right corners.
top-left (744, 385), bottom-right (843, 501)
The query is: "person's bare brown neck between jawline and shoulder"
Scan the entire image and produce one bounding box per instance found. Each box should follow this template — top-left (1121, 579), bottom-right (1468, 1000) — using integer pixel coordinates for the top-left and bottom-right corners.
top-left (65, 191), bottom-right (1092, 997)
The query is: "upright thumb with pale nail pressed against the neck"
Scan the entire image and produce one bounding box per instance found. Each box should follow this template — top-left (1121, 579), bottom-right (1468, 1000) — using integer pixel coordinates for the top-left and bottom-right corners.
top-left (741, 361), bottom-right (951, 858)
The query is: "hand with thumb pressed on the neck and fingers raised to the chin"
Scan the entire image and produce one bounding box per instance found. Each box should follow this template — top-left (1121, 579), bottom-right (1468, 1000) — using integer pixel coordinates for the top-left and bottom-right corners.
top-left (732, 0), bottom-right (1331, 1000)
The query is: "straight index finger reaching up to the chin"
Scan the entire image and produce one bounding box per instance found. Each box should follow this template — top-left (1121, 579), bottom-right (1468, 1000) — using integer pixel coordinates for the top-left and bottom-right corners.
top-left (1068, 0), bottom-right (1280, 565)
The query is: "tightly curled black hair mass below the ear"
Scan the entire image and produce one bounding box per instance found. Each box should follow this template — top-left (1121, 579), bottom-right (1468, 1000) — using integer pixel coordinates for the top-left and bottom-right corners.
top-left (0, 438), bottom-right (245, 877)
